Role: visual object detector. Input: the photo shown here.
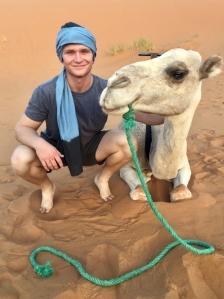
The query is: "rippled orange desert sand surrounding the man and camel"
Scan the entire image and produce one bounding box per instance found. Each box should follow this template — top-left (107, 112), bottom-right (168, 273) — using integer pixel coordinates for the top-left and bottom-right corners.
top-left (0, 0), bottom-right (224, 299)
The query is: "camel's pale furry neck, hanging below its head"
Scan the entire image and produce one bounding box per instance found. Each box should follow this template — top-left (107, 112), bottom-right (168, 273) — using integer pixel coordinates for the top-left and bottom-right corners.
top-left (150, 91), bottom-right (199, 179)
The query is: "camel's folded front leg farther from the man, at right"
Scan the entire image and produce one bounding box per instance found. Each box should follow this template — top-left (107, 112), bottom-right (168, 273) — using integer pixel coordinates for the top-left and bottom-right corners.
top-left (170, 161), bottom-right (192, 202)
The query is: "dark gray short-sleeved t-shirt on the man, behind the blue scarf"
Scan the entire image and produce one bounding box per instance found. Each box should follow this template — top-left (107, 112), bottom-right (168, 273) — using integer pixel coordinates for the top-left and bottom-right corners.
top-left (25, 75), bottom-right (107, 147)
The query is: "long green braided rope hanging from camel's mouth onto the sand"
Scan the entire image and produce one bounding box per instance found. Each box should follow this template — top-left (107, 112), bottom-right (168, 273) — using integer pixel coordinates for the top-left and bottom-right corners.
top-left (30, 106), bottom-right (215, 286)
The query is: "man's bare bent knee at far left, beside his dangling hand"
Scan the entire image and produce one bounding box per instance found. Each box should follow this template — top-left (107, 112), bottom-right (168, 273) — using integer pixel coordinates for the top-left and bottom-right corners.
top-left (11, 145), bottom-right (36, 175)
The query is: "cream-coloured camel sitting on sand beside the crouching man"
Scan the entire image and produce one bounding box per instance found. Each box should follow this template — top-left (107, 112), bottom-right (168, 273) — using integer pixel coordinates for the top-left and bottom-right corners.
top-left (100, 49), bottom-right (223, 202)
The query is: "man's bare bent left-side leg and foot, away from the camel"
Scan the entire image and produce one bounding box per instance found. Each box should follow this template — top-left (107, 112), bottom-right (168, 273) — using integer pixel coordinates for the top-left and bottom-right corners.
top-left (11, 145), bottom-right (56, 213)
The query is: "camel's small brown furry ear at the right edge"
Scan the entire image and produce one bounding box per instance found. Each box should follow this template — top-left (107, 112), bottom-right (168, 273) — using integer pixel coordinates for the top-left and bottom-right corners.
top-left (199, 55), bottom-right (223, 80)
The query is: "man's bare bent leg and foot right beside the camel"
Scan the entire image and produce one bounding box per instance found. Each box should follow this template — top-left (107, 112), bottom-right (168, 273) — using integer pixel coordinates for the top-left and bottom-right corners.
top-left (95, 130), bottom-right (137, 201)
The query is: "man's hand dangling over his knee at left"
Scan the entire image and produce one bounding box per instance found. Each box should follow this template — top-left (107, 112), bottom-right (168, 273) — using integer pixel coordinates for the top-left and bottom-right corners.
top-left (35, 138), bottom-right (64, 171)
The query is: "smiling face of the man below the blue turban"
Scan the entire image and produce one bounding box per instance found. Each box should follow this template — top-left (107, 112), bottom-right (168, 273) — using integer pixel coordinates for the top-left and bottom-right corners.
top-left (62, 44), bottom-right (94, 78)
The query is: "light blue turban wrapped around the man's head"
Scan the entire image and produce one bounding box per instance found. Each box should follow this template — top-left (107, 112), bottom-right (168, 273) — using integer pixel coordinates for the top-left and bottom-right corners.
top-left (56, 26), bottom-right (97, 62)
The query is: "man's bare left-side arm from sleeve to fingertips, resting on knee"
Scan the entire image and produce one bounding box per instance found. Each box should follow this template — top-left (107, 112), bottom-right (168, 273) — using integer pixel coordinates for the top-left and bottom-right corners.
top-left (15, 114), bottom-right (64, 171)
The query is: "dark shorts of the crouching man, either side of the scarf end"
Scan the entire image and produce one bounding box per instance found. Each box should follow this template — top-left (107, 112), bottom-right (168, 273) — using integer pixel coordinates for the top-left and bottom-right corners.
top-left (40, 131), bottom-right (108, 170)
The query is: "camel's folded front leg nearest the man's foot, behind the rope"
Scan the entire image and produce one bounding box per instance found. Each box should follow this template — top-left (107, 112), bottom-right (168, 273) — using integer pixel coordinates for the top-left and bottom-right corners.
top-left (120, 164), bottom-right (151, 200)
